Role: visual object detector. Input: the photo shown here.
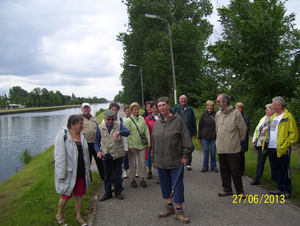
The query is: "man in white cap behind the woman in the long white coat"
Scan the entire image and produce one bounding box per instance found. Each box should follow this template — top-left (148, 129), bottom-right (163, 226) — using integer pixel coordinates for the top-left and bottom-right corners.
top-left (81, 103), bottom-right (105, 181)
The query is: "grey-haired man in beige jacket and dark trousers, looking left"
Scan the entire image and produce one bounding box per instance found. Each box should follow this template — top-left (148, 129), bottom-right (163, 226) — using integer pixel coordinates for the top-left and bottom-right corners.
top-left (215, 94), bottom-right (247, 198)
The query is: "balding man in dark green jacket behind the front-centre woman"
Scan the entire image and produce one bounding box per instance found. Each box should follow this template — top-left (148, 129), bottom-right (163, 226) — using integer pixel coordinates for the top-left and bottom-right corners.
top-left (172, 95), bottom-right (197, 170)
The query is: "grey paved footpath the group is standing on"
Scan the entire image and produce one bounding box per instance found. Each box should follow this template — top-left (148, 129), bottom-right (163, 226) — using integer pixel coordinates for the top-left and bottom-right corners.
top-left (89, 106), bottom-right (300, 226)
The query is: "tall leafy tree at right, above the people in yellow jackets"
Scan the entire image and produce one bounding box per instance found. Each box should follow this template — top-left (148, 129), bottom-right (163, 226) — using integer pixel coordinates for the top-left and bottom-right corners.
top-left (209, 0), bottom-right (299, 107)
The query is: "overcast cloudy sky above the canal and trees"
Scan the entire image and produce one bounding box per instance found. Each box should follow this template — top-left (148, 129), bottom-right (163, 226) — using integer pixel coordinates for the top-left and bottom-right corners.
top-left (0, 0), bottom-right (300, 100)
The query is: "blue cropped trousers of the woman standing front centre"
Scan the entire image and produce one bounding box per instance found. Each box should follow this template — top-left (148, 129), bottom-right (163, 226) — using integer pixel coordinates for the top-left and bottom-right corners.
top-left (157, 167), bottom-right (184, 204)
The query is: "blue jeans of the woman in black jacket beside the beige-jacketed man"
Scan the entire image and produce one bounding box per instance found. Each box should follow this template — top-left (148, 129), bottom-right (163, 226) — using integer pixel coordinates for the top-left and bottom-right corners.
top-left (202, 139), bottom-right (217, 169)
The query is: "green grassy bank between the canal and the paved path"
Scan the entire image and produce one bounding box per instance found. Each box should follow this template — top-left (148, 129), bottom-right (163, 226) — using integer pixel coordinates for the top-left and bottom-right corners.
top-left (0, 146), bottom-right (101, 226)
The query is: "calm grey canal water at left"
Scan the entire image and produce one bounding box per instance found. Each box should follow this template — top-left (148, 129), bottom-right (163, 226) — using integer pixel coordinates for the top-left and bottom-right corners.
top-left (0, 103), bottom-right (109, 183)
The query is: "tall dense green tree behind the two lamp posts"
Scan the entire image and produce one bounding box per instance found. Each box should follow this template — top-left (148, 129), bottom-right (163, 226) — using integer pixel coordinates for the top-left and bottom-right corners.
top-left (118, 0), bottom-right (212, 106)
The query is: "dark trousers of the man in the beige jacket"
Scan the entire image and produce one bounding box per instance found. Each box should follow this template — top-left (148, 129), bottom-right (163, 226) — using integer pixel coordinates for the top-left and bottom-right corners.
top-left (219, 153), bottom-right (244, 194)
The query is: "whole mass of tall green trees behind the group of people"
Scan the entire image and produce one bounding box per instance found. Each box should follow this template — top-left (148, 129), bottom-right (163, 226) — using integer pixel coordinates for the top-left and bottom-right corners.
top-left (116, 0), bottom-right (300, 132)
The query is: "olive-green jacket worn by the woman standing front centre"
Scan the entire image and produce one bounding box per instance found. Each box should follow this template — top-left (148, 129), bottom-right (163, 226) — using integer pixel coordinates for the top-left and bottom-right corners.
top-left (151, 112), bottom-right (194, 169)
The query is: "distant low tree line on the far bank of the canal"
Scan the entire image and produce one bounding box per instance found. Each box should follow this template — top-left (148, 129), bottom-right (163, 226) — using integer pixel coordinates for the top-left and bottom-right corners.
top-left (0, 86), bottom-right (107, 107)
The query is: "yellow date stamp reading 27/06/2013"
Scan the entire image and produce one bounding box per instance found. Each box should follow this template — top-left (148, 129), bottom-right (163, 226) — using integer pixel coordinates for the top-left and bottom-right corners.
top-left (232, 194), bottom-right (285, 204)
